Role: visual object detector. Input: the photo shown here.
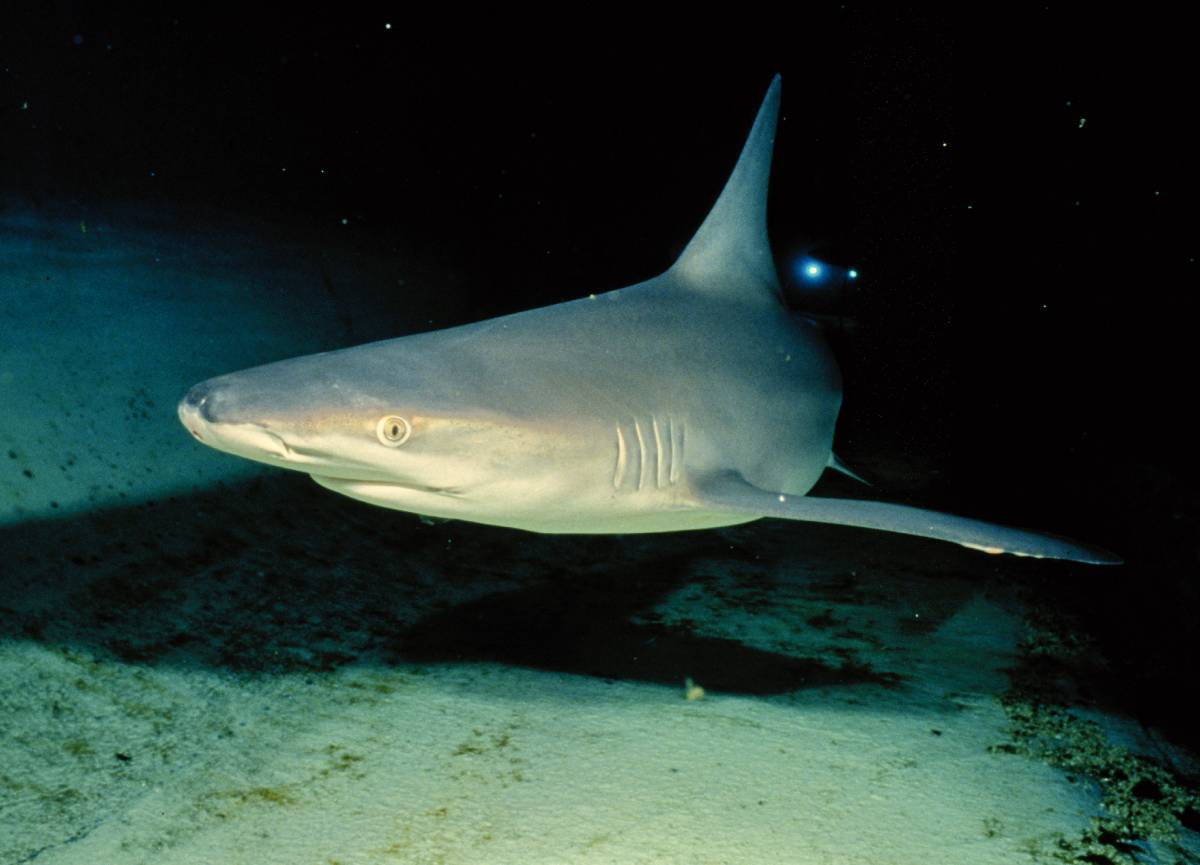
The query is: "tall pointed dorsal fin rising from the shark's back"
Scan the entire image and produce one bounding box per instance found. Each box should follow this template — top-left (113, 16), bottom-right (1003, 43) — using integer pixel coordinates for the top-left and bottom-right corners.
top-left (671, 76), bottom-right (780, 298)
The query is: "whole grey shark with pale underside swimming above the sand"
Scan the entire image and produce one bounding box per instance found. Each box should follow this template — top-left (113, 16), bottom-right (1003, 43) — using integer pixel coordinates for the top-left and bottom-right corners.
top-left (179, 76), bottom-right (1118, 564)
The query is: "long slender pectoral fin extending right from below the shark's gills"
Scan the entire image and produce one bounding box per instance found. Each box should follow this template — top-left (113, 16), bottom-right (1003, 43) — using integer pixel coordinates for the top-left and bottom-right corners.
top-left (694, 471), bottom-right (1121, 565)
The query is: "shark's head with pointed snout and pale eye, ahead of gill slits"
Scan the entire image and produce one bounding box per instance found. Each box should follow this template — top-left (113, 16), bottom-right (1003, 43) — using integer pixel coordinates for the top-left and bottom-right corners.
top-left (178, 337), bottom-right (590, 517)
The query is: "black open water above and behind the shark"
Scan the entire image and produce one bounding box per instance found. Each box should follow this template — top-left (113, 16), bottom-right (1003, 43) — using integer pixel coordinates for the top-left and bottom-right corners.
top-left (0, 2), bottom-right (1200, 743)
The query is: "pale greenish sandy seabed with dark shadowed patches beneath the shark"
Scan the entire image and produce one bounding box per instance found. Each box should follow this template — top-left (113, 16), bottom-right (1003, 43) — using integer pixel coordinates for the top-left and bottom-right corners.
top-left (0, 208), bottom-right (1200, 865)
